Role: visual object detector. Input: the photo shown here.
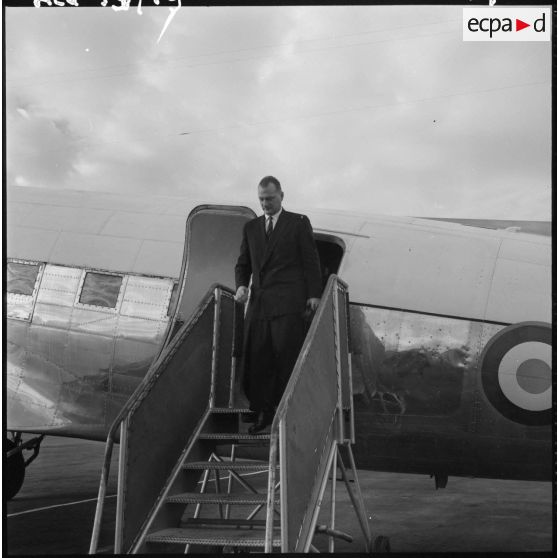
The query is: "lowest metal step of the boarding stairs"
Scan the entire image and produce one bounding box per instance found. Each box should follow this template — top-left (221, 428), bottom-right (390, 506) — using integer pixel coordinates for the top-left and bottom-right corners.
top-left (146, 526), bottom-right (281, 547)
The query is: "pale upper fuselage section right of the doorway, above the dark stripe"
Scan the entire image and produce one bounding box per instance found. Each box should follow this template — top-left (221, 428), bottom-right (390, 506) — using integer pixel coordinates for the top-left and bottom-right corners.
top-left (339, 220), bottom-right (552, 324)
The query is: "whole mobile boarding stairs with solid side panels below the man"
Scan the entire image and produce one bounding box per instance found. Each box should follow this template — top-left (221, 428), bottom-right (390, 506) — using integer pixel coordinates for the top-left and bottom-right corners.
top-left (90, 275), bottom-right (371, 554)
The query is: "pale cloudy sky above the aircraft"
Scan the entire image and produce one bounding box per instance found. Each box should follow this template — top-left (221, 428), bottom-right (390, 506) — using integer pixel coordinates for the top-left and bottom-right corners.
top-left (5, 2), bottom-right (552, 220)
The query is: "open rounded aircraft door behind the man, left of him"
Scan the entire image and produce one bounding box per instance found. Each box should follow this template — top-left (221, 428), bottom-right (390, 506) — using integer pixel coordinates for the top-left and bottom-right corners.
top-left (161, 205), bottom-right (256, 350)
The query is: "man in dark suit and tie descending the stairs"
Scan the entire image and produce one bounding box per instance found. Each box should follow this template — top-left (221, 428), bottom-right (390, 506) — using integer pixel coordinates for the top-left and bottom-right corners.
top-left (235, 176), bottom-right (322, 433)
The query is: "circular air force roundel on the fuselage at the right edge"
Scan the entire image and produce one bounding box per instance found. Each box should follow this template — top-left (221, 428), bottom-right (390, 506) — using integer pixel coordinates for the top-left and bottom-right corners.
top-left (481, 322), bottom-right (553, 426)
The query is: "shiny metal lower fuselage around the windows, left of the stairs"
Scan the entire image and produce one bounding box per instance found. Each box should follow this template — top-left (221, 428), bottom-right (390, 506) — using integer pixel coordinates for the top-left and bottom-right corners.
top-left (7, 264), bottom-right (173, 439)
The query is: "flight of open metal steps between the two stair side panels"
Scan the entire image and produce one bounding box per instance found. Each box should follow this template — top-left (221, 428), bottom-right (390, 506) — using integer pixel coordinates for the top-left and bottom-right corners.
top-left (134, 407), bottom-right (281, 553)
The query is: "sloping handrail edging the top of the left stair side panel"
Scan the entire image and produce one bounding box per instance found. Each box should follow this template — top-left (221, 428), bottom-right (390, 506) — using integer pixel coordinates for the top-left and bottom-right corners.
top-left (89, 283), bottom-right (234, 554)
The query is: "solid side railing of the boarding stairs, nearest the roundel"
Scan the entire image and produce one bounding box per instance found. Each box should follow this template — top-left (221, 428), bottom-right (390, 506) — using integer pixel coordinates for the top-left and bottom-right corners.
top-left (265, 275), bottom-right (353, 552)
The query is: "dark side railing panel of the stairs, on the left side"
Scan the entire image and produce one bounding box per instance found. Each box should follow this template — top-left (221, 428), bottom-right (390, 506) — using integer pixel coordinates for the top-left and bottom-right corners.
top-left (89, 285), bottom-right (238, 554)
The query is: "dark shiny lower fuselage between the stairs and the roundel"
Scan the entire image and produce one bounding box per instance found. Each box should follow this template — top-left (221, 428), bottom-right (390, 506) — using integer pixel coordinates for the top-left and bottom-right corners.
top-left (351, 305), bottom-right (553, 480)
